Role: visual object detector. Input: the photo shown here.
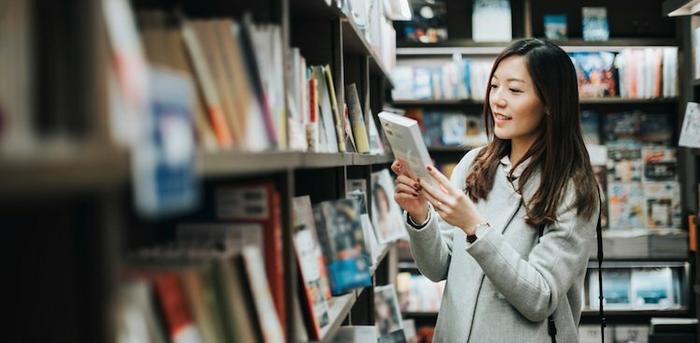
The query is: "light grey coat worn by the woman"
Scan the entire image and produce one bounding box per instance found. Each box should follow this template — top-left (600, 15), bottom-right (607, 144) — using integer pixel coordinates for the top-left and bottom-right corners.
top-left (406, 149), bottom-right (597, 342)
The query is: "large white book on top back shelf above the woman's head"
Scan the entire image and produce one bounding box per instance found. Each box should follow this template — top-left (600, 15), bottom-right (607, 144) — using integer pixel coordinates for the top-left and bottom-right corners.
top-left (472, 0), bottom-right (513, 42)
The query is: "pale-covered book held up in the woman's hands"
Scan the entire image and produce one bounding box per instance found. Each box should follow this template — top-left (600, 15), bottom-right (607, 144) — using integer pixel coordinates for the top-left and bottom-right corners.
top-left (379, 112), bottom-right (435, 184)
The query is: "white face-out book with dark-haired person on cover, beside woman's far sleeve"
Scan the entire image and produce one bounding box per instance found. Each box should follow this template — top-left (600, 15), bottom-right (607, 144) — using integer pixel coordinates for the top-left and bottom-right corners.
top-left (372, 169), bottom-right (406, 244)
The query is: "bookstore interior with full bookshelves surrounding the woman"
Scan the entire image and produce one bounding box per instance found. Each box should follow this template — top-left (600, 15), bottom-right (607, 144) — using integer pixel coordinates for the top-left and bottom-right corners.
top-left (0, 0), bottom-right (700, 343)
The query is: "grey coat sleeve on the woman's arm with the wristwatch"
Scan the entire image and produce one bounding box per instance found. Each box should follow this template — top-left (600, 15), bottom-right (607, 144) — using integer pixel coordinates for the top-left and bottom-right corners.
top-left (466, 185), bottom-right (600, 322)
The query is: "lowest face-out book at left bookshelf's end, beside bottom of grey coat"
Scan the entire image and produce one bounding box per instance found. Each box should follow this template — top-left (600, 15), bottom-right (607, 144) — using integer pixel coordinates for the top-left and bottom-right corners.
top-left (374, 284), bottom-right (403, 340)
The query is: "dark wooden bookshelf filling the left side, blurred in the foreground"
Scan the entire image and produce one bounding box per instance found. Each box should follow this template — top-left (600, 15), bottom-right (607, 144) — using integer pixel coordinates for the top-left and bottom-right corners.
top-left (0, 0), bottom-right (404, 342)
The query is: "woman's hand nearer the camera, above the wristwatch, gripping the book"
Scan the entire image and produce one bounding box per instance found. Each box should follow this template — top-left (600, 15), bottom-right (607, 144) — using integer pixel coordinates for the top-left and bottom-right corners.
top-left (420, 166), bottom-right (485, 235)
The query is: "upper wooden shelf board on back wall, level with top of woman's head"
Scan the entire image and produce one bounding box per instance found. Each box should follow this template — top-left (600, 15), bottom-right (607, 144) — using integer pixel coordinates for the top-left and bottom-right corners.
top-left (396, 38), bottom-right (679, 56)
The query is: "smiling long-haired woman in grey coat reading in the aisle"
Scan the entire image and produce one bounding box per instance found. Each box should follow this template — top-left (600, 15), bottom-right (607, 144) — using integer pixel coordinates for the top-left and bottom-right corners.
top-left (392, 39), bottom-right (600, 342)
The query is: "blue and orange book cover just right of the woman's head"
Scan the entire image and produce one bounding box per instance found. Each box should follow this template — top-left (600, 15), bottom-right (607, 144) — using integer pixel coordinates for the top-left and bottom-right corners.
top-left (569, 51), bottom-right (618, 98)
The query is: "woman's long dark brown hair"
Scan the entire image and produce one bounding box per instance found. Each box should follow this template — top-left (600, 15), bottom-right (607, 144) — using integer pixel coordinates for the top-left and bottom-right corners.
top-left (465, 39), bottom-right (597, 226)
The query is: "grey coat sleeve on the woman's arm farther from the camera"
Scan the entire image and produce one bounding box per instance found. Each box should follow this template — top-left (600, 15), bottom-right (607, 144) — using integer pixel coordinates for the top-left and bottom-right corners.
top-left (404, 149), bottom-right (479, 282)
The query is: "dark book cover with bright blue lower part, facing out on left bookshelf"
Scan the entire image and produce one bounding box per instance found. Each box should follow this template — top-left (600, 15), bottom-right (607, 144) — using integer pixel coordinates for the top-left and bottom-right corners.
top-left (314, 199), bottom-right (372, 295)
